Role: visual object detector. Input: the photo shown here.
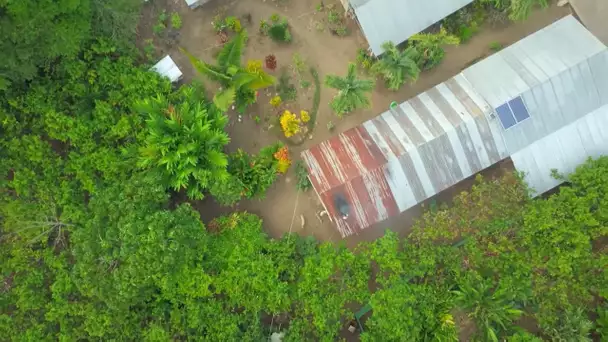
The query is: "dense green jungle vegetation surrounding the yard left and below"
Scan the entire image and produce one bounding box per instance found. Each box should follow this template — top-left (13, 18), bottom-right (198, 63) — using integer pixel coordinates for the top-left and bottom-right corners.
top-left (0, 0), bottom-right (608, 341)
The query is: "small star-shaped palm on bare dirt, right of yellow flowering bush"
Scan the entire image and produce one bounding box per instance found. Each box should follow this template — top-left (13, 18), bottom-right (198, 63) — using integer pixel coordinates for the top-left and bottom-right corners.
top-left (325, 63), bottom-right (375, 117)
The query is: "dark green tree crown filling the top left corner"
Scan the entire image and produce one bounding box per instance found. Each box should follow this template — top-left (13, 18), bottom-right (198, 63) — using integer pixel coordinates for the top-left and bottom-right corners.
top-left (0, 0), bottom-right (91, 85)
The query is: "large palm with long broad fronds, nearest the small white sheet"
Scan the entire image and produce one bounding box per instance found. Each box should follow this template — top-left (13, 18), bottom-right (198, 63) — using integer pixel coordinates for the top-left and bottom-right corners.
top-left (182, 30), bottom-right (275, 112)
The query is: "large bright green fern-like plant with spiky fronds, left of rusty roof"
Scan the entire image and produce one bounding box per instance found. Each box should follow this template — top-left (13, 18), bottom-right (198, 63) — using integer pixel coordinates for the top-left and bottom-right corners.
top-left (137, 88), bottom-right (230, 199)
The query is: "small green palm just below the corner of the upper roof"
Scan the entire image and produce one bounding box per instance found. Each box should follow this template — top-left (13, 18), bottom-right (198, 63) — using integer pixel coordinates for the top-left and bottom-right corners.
top-left (372, 42), bottom-right (420, 90)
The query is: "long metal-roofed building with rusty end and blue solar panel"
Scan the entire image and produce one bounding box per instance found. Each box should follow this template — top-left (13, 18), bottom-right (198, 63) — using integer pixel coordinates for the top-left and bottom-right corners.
top-left (302, 16), bottom-right (608, 237)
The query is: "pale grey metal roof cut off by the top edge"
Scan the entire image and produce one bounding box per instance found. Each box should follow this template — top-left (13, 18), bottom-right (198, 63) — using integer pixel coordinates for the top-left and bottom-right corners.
top-left (350, 0), bottom-right (473, 55)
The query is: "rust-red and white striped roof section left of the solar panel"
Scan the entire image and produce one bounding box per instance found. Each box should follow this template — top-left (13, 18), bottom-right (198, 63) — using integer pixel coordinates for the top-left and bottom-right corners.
top-left (302, 75), bottom-right (507, 236)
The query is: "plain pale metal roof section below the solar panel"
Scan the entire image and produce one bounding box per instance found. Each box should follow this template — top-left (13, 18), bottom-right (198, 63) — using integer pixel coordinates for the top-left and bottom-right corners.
top-left (511, 105), bottom-right (608, 194)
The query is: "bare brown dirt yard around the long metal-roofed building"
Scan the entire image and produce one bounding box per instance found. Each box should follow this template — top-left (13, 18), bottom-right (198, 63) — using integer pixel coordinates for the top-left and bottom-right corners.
top-left (138, 0), bottom-right (570, 245)
